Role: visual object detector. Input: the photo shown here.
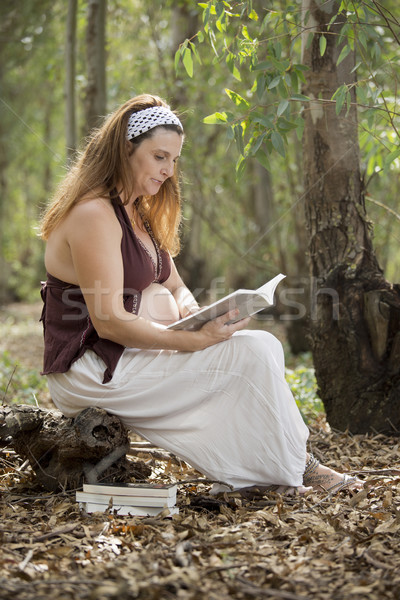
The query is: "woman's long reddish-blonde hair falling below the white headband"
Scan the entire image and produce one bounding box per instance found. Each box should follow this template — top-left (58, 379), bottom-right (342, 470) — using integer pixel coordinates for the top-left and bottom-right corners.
top-left (40, 94), bottom-right (183, 256)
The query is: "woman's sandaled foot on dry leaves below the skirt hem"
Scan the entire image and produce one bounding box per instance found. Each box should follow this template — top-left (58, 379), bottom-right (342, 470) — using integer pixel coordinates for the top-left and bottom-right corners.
top-left (303, 454), bottom-right (364, 494)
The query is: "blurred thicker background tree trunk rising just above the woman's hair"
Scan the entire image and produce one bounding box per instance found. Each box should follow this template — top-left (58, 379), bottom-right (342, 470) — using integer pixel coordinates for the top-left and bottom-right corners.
top-left (85, 0), bottom-right (107, 132)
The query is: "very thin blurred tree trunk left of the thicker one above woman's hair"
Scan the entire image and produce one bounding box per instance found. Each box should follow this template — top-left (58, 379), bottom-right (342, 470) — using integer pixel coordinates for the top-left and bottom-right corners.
top-left (65, 0), bottom-right (78, 162)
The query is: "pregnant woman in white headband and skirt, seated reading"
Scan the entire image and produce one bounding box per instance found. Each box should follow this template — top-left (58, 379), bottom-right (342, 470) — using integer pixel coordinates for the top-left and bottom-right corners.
top-left (42, 95), bottom-right (360, 492)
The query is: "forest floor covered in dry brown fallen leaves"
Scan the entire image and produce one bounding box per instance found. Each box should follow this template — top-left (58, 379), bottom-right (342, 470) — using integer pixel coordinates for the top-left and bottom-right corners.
top-left (0, 305), bottom-right (400, 600)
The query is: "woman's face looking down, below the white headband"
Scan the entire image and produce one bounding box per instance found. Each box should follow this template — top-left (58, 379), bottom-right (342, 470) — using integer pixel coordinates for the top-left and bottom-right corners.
top-left (129, 127), bottom-right (183, 198)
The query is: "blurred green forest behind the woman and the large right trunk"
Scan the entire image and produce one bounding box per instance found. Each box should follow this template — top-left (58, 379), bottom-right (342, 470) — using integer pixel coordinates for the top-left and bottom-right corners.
top-left (0, 0), bottom-right (400, 430)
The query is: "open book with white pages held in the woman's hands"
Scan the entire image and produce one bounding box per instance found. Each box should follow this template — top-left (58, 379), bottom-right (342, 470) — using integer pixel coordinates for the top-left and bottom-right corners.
top-left (168, 274), bottom-right (285, 331)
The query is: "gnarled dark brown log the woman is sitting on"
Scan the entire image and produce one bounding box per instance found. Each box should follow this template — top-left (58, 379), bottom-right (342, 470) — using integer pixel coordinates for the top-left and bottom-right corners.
top-left (0, 405), bottom-right (151, 491)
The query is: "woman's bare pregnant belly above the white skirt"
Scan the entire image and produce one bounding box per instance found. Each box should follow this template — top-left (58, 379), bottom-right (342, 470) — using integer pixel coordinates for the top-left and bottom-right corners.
top-left (139, 283), bottom-right (179, 325)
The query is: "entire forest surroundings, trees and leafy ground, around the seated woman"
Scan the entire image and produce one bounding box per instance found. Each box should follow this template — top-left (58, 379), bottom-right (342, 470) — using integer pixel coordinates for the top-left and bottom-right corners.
top-left (0, 0), bottom-right (400, 600)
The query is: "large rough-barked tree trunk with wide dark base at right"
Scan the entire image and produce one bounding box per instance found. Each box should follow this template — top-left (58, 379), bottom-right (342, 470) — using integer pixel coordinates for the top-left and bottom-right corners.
top-left (302, 0), bottom-right (400, 434)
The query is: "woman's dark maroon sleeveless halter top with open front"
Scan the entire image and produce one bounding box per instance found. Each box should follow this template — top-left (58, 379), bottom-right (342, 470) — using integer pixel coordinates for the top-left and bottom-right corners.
top-left (40, 198), bottom-right (171, 383)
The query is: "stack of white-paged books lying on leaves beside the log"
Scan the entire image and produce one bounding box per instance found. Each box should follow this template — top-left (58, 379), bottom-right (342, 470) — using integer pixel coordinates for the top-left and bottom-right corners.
top-left (76, 483), bottom-right (179, 517)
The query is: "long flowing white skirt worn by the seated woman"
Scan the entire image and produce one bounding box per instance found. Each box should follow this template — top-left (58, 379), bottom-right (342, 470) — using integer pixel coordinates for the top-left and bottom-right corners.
top-left (48, 330), bottom-right (308, 489)
